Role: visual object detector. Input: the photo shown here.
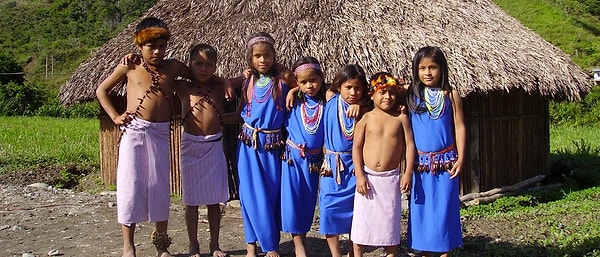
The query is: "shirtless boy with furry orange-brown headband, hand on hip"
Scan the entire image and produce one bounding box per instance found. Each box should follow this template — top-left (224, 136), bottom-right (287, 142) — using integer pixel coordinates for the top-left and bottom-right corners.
top-left (96, 17), bottom-right (192, 257)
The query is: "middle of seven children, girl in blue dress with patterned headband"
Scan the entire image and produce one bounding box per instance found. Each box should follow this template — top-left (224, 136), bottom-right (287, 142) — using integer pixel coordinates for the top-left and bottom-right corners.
top-left (281, 57), bottom-right (326, 257)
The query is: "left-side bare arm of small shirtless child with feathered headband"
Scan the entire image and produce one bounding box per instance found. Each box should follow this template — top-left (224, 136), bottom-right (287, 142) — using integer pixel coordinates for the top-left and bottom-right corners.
top-left (352, 114), bottom-right (370, 195)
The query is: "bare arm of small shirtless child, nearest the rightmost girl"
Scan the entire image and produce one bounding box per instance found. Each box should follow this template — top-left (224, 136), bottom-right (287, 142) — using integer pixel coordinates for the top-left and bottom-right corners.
top-left (400, 114), bottom-right (417, 193)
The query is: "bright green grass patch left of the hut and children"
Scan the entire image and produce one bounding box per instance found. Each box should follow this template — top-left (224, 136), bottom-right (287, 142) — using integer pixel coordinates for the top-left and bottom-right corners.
top-left (0, 117), bottom-right (100, 173)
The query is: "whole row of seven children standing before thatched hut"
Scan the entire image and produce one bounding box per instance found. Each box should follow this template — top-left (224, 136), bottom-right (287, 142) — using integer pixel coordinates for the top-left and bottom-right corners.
top-left (96, 18), bottom-right (466, 257)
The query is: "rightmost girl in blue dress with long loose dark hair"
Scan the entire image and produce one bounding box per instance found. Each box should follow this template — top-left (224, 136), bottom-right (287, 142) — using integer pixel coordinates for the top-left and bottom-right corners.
top-left (407, 46), bottom-right (466, 256)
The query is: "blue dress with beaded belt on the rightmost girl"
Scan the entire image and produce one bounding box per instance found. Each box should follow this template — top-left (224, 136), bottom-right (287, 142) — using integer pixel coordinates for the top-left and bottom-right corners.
top-left (408, 93), bottom-right (462, 252)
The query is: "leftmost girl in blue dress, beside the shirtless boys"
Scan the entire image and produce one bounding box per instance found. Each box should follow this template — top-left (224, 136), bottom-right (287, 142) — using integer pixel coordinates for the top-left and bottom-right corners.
top-left (237, 33), bottom-right (295, 257)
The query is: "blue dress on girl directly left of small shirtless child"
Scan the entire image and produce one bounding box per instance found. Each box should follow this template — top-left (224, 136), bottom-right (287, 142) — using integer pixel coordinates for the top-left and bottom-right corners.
top-left (319, 94), bottom-right (356, 235)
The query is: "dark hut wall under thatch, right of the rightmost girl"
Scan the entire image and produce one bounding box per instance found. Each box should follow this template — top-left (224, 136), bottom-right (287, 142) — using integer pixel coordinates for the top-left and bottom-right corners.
top-left (461, 90), bottom-right (550, 194)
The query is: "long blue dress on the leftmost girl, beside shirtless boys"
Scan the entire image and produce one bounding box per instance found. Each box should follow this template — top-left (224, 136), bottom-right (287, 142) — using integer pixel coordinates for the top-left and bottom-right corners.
top-left (237, 74), bottom-right (288, 251)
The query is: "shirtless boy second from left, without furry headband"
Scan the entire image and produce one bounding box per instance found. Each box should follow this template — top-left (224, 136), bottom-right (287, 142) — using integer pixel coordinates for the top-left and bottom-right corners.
top-left (177, 44), bottom-right (229, 257)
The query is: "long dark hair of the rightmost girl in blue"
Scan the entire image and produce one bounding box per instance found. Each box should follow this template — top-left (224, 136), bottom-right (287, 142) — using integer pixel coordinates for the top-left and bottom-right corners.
top-left (406, 46), bottom-right (452, 113)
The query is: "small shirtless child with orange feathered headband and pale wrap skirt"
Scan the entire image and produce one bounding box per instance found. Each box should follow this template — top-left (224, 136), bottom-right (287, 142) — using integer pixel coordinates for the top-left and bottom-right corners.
top-left (350, 72), bottom-right (416, 257)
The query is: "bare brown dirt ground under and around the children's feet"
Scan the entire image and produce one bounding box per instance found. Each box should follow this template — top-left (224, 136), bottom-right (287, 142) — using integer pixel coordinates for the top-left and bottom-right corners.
top-left (0, 167), bottom-right (536, 257)
